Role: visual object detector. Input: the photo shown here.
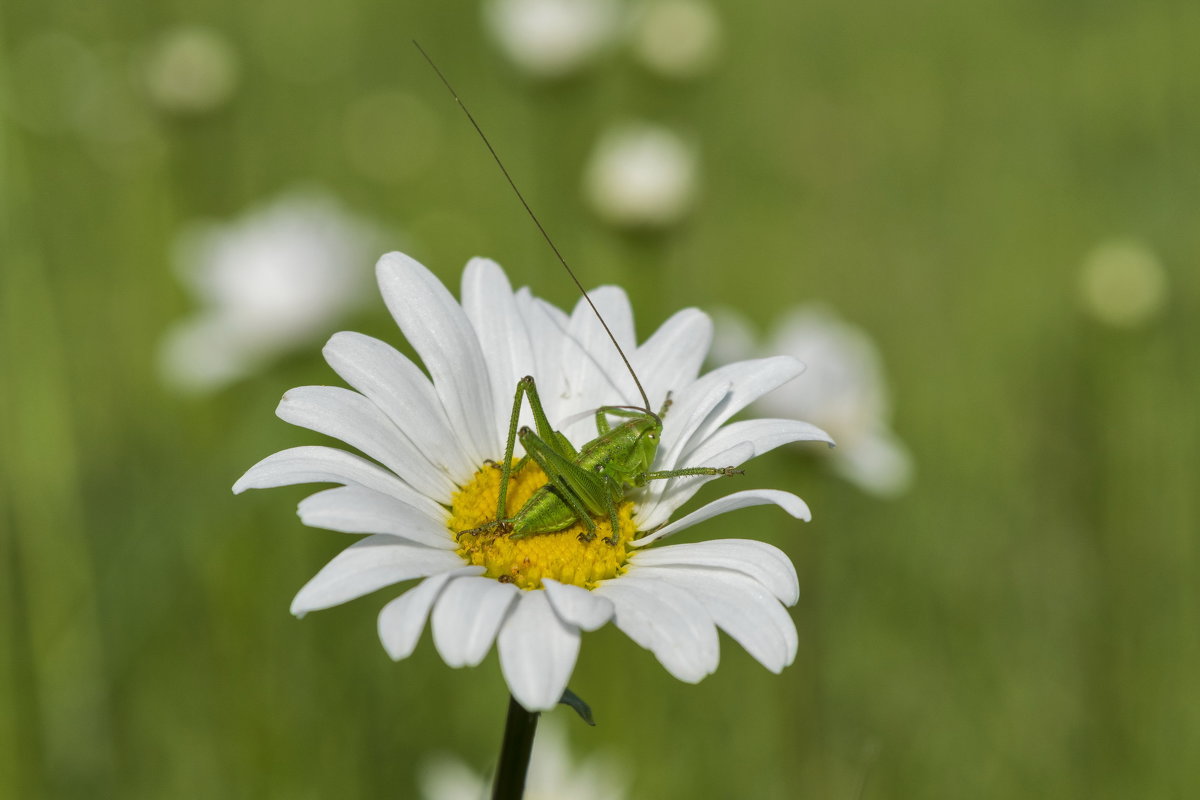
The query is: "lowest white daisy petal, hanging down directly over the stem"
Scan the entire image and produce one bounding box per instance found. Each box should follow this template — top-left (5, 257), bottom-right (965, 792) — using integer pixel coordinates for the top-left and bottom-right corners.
top-left (498, 590), bottom-right (580, 711)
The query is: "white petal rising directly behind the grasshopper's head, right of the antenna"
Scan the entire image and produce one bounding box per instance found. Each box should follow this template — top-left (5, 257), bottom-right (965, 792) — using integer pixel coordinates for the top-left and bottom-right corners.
top-left (630, 308), bottom-right (713, 411)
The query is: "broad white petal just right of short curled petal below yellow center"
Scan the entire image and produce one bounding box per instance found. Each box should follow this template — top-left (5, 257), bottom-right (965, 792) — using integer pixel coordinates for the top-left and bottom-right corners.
top-left (596, 575), bottom-right (720, 684)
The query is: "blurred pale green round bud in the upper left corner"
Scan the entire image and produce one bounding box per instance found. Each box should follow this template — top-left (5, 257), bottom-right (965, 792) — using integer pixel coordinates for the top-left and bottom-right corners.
top-left (144, 25), bottom-right (240, 114)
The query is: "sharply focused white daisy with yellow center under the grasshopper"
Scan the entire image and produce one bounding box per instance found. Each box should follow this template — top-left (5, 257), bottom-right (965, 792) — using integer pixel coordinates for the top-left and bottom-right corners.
top-left (234, 253), bottom-right (829, 711)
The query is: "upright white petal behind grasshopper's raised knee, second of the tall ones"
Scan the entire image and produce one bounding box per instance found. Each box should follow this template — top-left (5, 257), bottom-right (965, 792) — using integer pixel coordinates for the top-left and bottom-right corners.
top-left (462, 258), bottom-right (536, 435)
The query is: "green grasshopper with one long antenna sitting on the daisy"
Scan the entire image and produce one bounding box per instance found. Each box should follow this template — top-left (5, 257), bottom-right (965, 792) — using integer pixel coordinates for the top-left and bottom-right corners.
top-left (413, 41), bottom-right (742, 546)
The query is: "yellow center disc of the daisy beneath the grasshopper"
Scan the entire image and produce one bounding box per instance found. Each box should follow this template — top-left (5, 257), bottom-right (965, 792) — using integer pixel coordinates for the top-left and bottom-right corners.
top-left (448, 462), bottom-right (636, 589)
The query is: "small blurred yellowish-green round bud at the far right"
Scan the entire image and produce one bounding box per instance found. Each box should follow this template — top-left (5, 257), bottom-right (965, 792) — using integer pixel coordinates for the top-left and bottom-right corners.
top-left (1079, 239), bottom-right (1166, 327)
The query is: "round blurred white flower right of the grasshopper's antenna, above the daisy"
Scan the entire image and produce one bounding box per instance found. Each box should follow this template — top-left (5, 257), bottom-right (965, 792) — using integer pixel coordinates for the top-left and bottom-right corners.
top-left (583, 122), bottom-right (697, 228)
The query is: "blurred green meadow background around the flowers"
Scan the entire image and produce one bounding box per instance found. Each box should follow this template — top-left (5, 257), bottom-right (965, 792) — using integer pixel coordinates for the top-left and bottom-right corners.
top-left (0, 0), bottom-right (1200, 800)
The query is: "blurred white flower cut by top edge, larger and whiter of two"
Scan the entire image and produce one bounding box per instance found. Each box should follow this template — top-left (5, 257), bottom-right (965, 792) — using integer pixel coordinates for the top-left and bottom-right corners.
top-left (484, 0), bottom-right (619, 78)
